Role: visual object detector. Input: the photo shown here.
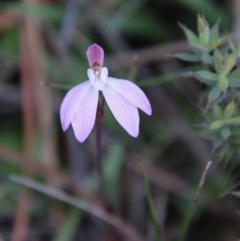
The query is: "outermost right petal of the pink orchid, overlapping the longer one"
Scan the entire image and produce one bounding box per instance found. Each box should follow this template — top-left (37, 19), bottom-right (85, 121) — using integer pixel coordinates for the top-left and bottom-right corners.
top-left (107, 77), bottom-right (152, 115)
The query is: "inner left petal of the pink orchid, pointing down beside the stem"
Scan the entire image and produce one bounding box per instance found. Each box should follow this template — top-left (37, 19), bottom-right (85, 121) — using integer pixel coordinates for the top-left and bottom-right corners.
top-left (72, 87), bottom-right (99, 142)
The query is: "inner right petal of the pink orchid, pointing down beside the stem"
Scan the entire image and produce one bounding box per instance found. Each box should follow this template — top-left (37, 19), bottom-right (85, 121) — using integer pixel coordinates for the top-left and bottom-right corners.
top-left (102, 84), bottom-right (139, 137)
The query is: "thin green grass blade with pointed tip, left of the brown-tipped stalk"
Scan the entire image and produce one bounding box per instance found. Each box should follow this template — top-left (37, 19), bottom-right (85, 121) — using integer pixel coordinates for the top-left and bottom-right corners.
top-left (139, 160), bottom-right (162, 241)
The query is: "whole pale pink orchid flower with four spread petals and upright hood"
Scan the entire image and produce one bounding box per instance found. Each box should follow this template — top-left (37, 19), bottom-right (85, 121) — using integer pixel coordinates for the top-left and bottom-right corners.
top-left (60, 44), bottom-right (152, 142)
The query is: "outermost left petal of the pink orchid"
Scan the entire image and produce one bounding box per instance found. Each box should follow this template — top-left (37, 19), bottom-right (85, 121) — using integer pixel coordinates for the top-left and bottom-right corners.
top-left (60, 81), bottom-right (91, 131)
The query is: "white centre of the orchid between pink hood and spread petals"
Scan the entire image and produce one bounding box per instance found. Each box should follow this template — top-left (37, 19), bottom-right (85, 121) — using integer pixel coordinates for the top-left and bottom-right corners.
top-left (87, 65), bottom-right (108, 90)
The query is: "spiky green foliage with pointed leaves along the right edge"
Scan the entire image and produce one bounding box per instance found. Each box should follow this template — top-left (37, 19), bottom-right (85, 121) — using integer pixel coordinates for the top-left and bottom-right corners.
top-left (175, 15), bottom-right (240, 160)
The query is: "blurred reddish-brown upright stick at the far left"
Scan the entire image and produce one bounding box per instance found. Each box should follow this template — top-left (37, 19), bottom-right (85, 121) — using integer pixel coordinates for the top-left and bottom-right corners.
top-left (11, 15), bottom-right (35, 241)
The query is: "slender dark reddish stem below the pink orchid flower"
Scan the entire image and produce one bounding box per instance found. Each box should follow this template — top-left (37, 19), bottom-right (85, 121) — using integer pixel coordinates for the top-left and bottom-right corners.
top-left (96, 99), bottom-right (105, 197)
